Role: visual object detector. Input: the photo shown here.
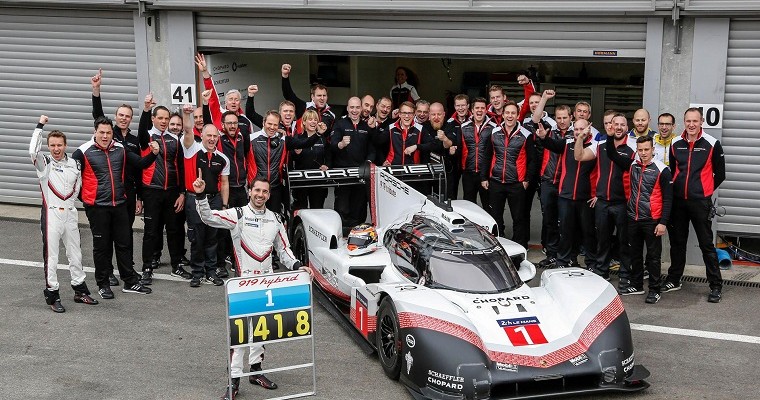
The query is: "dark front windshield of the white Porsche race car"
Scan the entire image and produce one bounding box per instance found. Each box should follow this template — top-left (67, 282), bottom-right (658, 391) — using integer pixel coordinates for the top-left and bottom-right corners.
top-left (426, 247), bottom-right (522, 293)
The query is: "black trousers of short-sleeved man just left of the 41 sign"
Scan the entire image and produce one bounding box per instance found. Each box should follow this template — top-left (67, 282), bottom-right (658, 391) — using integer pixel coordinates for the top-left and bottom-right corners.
top-left (142, 188), bottom-right (185, 270)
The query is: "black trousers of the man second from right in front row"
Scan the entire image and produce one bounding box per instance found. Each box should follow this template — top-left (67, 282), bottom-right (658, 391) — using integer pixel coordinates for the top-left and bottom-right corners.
top-left (628, 218), bottom-right (662, 293)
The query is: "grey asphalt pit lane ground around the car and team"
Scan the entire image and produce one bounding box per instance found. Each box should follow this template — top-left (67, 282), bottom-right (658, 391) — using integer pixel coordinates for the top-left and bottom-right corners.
top-left (0, 221), bottom-right (760, 399)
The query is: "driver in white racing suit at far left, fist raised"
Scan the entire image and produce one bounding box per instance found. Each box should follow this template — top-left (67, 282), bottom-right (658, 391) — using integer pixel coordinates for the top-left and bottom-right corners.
top-left (29, 115), bottom-right (98, 313)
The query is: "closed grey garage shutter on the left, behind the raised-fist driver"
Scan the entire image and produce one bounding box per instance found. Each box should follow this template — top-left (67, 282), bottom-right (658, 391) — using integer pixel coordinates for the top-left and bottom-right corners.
top-left (0, 8), bottom-right (137, 204)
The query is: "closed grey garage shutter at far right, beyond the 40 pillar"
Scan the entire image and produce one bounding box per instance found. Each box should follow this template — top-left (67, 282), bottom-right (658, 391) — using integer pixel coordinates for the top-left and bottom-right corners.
top-left (718, 20), bottom-right (760, 234)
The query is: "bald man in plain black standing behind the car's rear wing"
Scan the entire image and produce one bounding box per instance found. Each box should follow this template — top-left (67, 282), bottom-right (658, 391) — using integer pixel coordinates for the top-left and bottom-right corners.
top-left (330, 97), bottom-right (377, 232)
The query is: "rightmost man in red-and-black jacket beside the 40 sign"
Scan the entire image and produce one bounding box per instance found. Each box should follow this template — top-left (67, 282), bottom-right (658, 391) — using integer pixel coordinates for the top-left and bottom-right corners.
top-left (662, 107), bottom-right (726, 303)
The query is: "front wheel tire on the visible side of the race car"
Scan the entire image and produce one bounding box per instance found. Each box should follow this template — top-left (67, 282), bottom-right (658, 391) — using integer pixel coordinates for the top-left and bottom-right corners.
top-left (375, 297), bottom-right (401, 380)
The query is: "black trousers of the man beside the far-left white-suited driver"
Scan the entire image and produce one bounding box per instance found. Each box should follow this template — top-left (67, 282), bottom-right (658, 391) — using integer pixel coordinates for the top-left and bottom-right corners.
top-left (85, 204), bottom-right (138, 287)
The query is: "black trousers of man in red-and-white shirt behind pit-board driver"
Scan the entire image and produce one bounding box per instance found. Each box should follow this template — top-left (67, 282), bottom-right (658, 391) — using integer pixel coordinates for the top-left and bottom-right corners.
top-left (185, 193), bottom-right (221, 278)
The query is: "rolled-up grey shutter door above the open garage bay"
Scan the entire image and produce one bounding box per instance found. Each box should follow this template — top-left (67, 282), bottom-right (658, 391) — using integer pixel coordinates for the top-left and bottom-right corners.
top-left (196, 11), bottom-right (646, 59)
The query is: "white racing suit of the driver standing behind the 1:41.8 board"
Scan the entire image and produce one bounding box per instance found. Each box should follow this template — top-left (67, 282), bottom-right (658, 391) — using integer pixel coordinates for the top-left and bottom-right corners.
top-left (196, 197), bottom-right (300, 378)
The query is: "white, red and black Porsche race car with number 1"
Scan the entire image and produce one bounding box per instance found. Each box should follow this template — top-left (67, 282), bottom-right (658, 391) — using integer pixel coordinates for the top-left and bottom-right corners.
top-left (289, 164), bottom-right (649, 400)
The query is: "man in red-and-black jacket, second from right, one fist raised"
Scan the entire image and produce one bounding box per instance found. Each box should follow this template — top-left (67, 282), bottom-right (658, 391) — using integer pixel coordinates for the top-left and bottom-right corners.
top-left (605, 126), bottom-right (673, 304)
